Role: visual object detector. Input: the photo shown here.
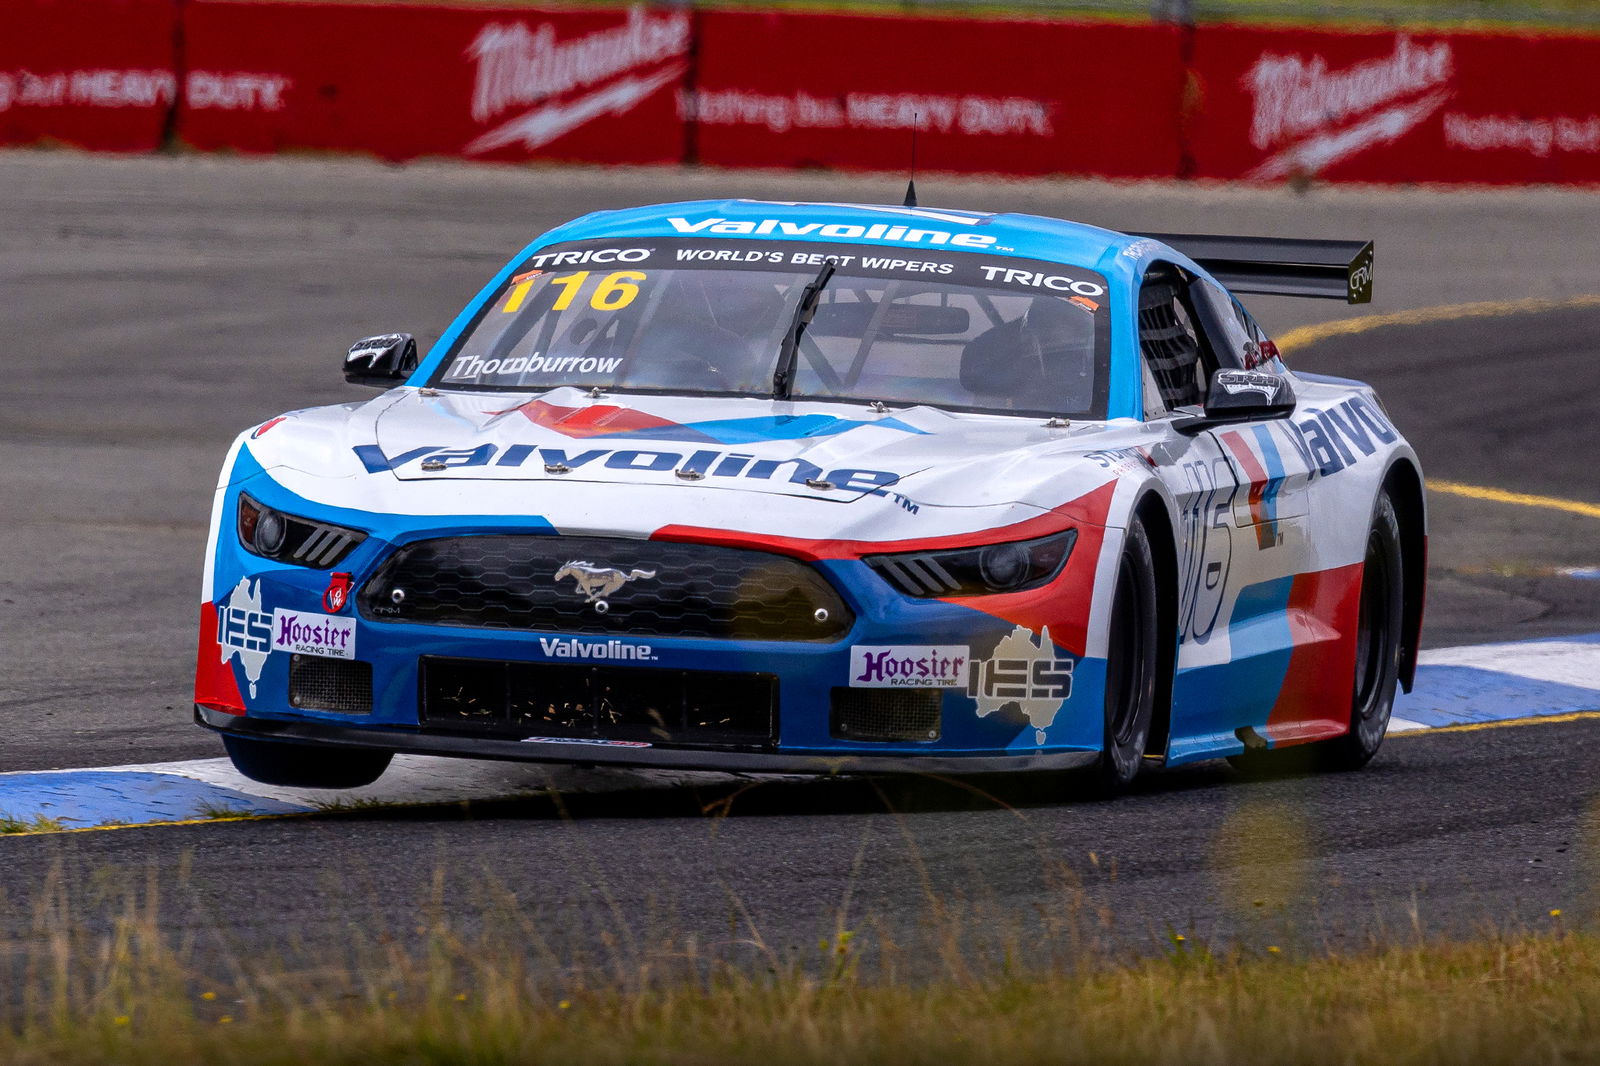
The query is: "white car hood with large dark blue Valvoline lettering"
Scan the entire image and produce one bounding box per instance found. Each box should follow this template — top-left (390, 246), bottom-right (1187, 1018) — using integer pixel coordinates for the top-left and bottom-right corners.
top-left (250, 387), bottom-right (1147, 525)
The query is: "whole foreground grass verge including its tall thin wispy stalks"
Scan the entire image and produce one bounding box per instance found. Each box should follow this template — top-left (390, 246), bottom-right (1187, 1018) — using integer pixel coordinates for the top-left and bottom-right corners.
top-left (0, 845), bottom-right (1580, 1066)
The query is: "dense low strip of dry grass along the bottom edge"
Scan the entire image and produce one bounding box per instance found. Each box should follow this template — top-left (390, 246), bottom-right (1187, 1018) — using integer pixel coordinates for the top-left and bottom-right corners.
top-left (0, 915), bottom-right (1600, 1066)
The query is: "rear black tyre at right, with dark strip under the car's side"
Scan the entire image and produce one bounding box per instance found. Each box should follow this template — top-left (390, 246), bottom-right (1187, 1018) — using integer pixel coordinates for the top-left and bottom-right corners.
top-left (1229, 491), bottom-right (1405, 776)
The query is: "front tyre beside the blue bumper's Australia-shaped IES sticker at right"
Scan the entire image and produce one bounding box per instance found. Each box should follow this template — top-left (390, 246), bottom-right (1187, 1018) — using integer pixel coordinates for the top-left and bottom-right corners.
top-left (1088, 519), bottom-right (1160, 797)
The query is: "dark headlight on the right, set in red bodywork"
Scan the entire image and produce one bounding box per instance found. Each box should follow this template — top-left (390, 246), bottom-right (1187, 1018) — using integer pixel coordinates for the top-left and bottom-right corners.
top-left (862, 530), bottom-right (1078, 597)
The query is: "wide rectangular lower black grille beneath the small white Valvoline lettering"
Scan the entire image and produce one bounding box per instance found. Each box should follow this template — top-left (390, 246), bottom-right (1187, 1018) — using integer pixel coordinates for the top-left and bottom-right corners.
top-left (421, 656), bottom-right (778, 746)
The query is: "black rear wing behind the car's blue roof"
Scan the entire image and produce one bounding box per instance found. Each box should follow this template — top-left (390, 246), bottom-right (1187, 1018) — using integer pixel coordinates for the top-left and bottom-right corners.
top-left (1131, 234), bottom-right (1373, 304)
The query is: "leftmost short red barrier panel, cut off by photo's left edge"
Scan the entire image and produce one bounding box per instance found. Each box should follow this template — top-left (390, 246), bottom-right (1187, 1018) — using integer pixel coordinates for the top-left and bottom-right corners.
top-left (0, 0), bottom-right (178, 152)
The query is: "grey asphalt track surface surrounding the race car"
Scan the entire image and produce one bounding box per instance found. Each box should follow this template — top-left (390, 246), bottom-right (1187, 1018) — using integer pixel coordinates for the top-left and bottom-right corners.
top-left (0, 154), bottom-right (1600, 952)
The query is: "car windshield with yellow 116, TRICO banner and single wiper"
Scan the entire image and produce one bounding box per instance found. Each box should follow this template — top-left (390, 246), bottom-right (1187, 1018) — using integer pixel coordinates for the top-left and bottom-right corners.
top-left (429, 238), bottom-right (1109, 418)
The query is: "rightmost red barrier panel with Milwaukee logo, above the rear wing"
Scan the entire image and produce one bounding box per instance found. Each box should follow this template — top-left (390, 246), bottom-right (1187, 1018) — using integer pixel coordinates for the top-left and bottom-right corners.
top-left (1189, 26), bottom-right (1600, 182)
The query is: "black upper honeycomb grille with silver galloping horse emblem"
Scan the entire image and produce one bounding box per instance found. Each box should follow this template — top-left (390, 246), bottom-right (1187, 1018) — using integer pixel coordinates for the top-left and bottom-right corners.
top-left (358, 535), bottom-right (854, 642)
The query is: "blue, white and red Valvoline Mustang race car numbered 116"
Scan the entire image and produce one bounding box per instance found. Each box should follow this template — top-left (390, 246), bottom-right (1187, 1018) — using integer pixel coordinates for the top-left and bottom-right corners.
top-left (195, 200), bottom-right (1426, 791)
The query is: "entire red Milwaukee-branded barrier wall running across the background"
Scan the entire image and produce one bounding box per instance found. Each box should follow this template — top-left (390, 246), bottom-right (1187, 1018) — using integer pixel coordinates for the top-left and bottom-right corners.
top-left (9, 0), bottom-right (1600, 184)
